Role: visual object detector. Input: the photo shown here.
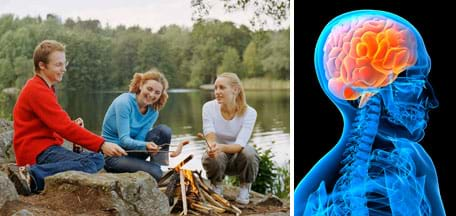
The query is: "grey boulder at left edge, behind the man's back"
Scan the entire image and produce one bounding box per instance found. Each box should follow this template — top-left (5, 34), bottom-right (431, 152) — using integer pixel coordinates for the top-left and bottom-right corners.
top-left (0, 119), bottom-right (16, 164)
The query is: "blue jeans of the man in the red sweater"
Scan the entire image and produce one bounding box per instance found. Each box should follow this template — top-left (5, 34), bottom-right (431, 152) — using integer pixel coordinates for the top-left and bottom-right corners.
top-left (30, 145), bottom-right (104, 192)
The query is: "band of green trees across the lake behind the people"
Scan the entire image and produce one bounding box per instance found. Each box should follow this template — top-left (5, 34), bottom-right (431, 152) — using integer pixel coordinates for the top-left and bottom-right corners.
top-left (0, 14), bottom-right (289, 91)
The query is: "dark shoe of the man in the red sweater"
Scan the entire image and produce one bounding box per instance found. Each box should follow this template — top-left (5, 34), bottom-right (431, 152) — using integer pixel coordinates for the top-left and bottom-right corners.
top-left (8, 164), bottom-right (32, 196)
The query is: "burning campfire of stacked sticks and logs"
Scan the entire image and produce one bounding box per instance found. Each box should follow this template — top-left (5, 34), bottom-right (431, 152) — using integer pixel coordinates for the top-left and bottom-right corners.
top-left (158, 155), bottom-right (242, 215)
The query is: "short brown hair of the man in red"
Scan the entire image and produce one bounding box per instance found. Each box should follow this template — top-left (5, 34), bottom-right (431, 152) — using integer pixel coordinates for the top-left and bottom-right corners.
top-left (33, 40), bottom-right (65, 72)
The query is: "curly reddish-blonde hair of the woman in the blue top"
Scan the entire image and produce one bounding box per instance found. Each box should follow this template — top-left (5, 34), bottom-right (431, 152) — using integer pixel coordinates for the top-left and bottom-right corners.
top-left (129, 69), bottom-right (169, 110)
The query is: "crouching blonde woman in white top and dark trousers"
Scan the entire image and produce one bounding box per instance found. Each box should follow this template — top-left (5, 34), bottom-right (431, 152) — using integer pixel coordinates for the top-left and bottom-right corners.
top-left (202, 73), bottom-right (260, 205)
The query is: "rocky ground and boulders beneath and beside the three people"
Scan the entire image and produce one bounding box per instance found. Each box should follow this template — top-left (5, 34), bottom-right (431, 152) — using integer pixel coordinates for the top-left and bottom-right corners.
top-left (0, 119), bottom-right (290, 216)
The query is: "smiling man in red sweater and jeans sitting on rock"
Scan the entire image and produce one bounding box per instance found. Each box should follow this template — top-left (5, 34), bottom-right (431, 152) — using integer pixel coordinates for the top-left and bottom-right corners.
top-left (9, 40), bottom-right (127, 195)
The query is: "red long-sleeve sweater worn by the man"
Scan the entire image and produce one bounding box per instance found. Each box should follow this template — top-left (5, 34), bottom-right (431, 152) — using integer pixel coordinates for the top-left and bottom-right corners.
top-left (13, 75), bottom-right (104, 166)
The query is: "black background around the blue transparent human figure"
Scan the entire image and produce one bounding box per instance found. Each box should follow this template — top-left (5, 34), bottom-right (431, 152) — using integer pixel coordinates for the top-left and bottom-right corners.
top-left (294, 0), bottom-right (456, 215)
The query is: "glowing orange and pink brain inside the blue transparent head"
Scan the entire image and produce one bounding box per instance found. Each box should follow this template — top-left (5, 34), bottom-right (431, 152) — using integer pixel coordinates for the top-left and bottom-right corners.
top-left (324, 17), bottom-right (416, 100)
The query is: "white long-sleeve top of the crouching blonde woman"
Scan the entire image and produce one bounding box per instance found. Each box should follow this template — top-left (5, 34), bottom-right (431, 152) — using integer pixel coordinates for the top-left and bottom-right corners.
top-left (203, 100), bottom-right (257, 147)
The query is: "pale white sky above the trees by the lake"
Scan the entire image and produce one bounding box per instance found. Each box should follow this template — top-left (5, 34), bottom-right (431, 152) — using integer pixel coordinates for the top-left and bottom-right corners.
top-left (0, 0), bottom-right (290, 32)
